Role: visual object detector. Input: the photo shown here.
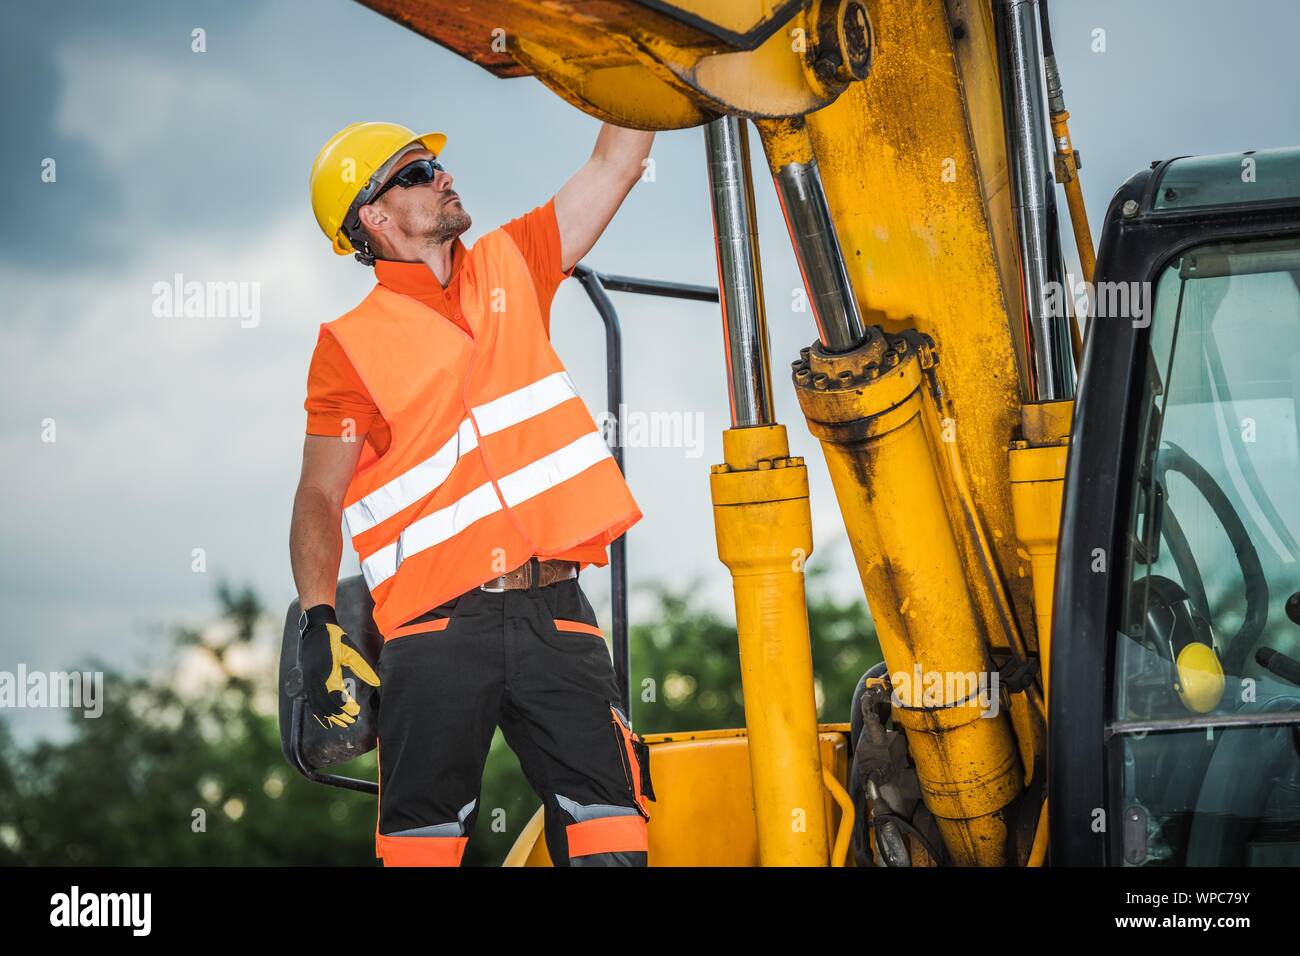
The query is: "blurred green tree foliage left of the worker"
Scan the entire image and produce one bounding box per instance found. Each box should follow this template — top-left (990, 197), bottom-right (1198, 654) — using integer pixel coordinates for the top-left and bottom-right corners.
top-left (0, 587), bottom-right (374, 866)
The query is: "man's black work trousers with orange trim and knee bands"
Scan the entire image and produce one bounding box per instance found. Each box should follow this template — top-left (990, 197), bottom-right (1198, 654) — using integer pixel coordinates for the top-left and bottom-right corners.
top-left (376, 568), bottom-right (653, 866)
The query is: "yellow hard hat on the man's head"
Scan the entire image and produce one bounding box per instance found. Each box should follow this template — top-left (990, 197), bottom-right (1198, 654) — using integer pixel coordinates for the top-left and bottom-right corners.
top-left (311, 122), bottom-right (447, 255)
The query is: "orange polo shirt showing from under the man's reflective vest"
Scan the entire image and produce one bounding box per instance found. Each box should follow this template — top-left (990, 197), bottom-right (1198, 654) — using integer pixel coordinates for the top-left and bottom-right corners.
top-left (304, 199), bottom-right (608, 566)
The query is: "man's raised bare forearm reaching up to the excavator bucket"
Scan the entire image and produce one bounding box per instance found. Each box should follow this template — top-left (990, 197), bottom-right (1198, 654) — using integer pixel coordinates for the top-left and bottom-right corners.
top-left (555, 124), bottom-right (654, 272)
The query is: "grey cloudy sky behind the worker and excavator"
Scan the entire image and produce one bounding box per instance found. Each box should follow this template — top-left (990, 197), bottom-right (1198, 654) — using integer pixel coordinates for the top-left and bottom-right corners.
top-left (0, 0), bottom-right (1300, 734)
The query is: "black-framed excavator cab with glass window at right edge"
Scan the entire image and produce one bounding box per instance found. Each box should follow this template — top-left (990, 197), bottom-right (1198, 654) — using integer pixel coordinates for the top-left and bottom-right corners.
top-left (1050, 148), bottom-right (1300, 866)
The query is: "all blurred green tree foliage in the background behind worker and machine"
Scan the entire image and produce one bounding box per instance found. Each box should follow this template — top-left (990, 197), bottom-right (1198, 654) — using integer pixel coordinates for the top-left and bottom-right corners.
top-left (0, 572), bottom-right (879, 866)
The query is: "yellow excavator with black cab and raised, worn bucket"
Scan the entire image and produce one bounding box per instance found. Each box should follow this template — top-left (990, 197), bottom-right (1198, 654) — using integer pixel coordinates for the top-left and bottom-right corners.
top-left (281, 0), bottom-right (1300, 866)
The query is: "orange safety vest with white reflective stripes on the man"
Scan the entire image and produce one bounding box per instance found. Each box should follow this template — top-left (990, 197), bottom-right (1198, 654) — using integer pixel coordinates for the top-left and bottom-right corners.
top-left (321, 229), bottom-right (641, 635)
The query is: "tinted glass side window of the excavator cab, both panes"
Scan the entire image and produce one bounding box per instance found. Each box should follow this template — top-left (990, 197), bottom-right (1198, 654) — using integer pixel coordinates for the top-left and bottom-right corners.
top-left (1099, 238), bottom-right (1300, 866)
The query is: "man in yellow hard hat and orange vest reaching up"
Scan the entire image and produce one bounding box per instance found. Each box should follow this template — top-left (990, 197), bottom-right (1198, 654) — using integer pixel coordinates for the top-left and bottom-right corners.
top-left (290, 122), bottom-right (654, 866)
